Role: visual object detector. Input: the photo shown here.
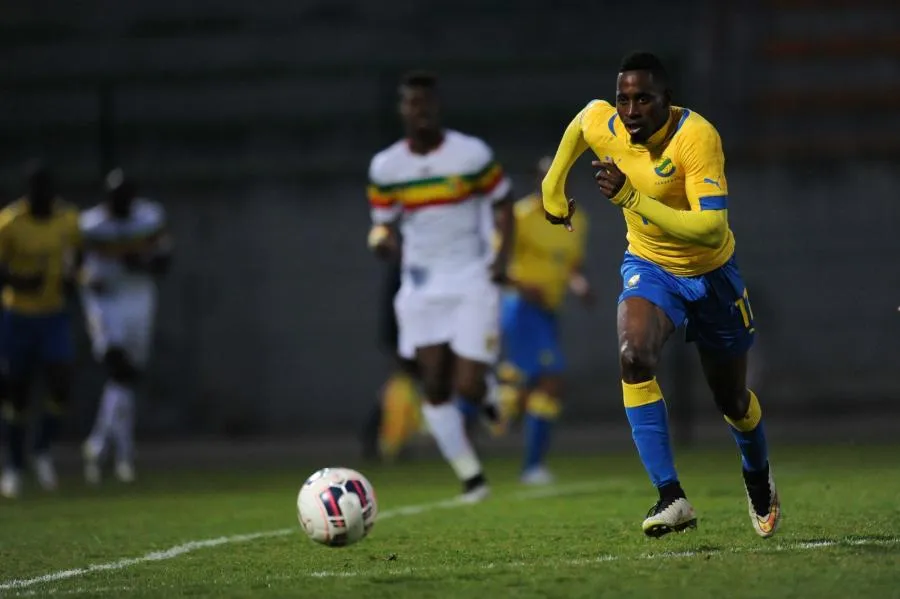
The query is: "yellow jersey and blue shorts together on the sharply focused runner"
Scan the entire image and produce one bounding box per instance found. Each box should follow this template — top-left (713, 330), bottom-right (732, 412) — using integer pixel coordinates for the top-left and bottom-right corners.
top-left (581, 101), bottom-right (756, 354)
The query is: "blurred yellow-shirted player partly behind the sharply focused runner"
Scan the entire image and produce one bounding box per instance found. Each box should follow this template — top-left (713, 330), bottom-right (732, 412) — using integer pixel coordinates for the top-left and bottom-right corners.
top-left (499, 157), bottom-right (593, 485)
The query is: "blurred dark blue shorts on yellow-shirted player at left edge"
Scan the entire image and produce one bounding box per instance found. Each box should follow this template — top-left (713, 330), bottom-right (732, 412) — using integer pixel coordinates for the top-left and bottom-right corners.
top-left (0, 312), bottom-right (75, 377)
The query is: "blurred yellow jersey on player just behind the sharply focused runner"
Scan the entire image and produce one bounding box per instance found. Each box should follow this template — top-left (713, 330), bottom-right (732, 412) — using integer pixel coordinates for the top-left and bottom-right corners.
top-left (508, 195), bottom-right (588, 311)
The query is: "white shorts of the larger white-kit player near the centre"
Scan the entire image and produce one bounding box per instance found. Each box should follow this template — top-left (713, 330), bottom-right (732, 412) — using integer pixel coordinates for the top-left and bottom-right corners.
top-left (394, 278), bottom-right (500, 364)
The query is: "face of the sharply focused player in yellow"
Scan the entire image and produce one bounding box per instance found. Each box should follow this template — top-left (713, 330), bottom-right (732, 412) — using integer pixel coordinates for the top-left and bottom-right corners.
top-left (616, 71), bottom-right (669, 144)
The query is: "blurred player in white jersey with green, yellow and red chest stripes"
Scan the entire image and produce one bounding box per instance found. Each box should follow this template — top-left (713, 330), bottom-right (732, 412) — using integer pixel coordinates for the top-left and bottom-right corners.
top-left (368, 72), bottom-right (513, 502)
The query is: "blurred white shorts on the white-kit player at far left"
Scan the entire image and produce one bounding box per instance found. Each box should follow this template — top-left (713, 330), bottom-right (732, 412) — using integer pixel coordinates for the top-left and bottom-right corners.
top-left (83, 292), bottom-right (156, 368)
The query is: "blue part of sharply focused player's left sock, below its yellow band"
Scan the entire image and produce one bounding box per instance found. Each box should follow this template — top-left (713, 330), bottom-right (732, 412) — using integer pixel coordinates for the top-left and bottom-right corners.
top-left (625, 400), bottom-right (678, 487)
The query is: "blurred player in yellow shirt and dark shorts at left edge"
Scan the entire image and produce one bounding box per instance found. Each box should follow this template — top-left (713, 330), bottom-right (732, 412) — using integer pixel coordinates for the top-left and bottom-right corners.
top-left (0, 165), bottom-right (80, 498)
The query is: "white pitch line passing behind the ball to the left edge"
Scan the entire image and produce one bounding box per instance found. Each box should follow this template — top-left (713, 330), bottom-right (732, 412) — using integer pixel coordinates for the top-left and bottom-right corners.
top-left (0, 480), bottom-right (617, 591)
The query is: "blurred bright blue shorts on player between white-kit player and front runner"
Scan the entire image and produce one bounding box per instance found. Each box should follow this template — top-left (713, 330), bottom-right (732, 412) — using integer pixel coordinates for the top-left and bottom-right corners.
top-left (500, 293), bottom-right (565, 385)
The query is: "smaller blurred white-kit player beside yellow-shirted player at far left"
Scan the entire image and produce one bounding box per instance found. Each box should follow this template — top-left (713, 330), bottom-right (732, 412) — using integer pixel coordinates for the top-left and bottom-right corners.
top-left (80, 169), bottom-right (172, 484)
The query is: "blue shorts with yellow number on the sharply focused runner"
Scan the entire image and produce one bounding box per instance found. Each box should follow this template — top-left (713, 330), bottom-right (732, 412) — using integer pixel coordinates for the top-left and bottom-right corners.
top-left (619, 252), bottom-right (756, 355)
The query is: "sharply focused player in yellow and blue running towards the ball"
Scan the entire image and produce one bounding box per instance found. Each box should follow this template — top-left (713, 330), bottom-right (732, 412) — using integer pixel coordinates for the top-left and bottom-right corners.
top-left (542, 53), bottom-right (781, 537)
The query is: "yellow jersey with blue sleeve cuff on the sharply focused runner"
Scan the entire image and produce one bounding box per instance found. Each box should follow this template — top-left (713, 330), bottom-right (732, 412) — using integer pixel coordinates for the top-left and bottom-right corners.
top-left (576, 100), bottom-right (734, 276)
